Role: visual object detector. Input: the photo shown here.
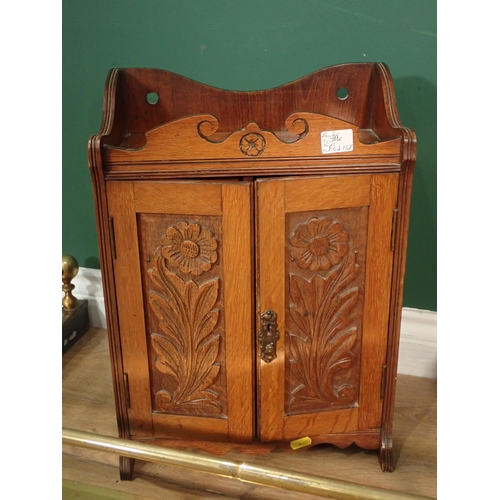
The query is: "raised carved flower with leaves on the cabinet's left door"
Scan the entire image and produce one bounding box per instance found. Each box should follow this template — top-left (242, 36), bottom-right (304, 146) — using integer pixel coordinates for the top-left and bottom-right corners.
top-left (148, 222), bottom-right (222, 415)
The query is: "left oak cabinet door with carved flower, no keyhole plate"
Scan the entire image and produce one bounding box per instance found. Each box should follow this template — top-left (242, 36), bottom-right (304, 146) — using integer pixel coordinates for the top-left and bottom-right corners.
top-left (107, 181), bottom-right (254, 442)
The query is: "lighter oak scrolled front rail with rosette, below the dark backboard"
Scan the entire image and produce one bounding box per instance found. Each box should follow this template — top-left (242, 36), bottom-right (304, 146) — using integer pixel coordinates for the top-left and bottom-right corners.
top-left (103, 112), bottom-right (401, 164)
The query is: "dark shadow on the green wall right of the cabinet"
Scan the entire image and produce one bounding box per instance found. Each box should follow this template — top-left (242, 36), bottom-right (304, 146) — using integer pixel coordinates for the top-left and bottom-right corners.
top-left (394, 77), bottom-right (437, 311)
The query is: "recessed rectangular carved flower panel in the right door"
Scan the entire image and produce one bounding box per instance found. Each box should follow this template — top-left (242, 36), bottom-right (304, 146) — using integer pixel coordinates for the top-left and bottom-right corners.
top-left (285, 207), bottom-right (367, 415)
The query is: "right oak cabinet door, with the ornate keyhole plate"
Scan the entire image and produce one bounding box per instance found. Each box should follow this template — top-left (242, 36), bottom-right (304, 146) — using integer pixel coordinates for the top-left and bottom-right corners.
top-left (256, 174), bottom-right (398, 441)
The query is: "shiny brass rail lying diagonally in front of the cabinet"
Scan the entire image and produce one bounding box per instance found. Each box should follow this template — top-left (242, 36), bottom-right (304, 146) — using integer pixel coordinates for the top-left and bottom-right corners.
top-left (62, 428), bottom-right (429, 500)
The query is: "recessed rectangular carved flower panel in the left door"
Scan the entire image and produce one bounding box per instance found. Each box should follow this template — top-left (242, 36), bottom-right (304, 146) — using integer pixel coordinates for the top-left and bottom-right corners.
top-left (139, 215), bottom-right (227, 418)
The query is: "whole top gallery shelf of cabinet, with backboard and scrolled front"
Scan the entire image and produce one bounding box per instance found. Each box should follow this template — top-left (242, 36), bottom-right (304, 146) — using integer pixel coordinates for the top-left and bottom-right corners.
top-left (89, 63), bottom-right (416, 175)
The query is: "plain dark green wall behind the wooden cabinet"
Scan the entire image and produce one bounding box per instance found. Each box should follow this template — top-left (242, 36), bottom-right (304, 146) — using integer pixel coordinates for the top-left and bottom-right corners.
top-left (62, 0), bottom-right (437, 311)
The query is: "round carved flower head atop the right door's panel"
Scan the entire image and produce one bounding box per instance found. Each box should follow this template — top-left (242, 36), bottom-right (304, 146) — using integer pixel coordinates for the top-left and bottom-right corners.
top-left (290, 217), bottom-right (349, 271)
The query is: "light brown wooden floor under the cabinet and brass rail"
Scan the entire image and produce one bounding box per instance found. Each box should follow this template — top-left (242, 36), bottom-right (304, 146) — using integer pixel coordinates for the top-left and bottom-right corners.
top-left (62, 328), bottom-right (437, 500)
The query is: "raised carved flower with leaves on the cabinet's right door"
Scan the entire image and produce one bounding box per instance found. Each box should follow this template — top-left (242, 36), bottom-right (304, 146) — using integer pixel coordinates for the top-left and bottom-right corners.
top-left (289, 218), bottom-right (359, 413)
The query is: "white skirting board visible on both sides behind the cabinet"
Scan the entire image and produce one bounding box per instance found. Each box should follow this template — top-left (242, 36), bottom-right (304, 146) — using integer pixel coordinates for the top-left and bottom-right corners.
top-left (68, 267), bottom-right (437, 379)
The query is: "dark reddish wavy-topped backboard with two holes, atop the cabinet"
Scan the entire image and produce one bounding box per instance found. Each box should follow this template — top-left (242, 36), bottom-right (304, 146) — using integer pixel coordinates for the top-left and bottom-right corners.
top-left (94, 63), bottom-right (394, 146)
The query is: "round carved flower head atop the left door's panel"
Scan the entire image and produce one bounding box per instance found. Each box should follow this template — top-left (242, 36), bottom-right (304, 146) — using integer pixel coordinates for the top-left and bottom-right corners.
top-left (161, 222), bottom-right (217, 276)
